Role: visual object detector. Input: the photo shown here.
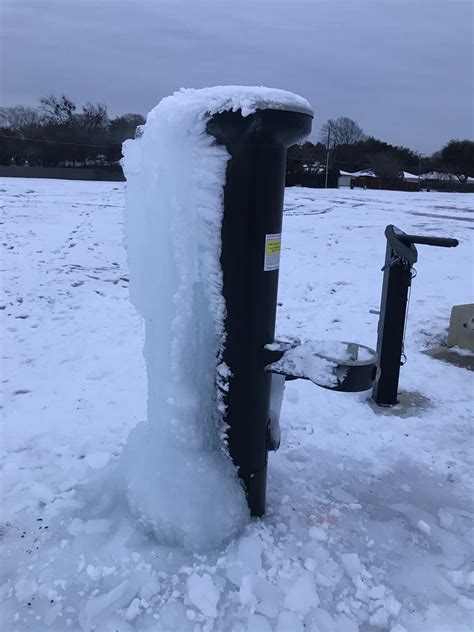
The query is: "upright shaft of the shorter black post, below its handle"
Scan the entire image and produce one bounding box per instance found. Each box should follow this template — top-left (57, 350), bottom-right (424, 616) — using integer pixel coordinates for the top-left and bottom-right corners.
top-left (373, 241), bottom-right (413, 406)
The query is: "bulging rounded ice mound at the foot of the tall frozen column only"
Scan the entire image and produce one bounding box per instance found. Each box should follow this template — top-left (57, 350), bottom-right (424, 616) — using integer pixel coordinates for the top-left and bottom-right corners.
top-left (122, 422), bottom-right (247, 550)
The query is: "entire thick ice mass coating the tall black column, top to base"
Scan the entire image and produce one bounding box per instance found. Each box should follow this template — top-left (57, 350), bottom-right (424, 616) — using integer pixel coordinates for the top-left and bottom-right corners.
top-left (122, 86), bottom-right (309, 549)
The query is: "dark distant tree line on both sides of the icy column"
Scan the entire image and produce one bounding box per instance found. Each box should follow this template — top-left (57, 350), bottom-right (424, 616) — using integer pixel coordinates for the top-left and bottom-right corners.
top-left (0, 95), bottom-right (474, 186)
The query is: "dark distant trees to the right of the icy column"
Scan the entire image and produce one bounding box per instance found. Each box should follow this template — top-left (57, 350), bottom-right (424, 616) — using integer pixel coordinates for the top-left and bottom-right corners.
top-left (288, 117), bottom-right (474, 182)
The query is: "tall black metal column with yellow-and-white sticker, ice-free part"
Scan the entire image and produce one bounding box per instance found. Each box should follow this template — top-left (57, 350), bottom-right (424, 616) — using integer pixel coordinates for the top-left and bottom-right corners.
top-left (208, 110), bottom-right (312, 516)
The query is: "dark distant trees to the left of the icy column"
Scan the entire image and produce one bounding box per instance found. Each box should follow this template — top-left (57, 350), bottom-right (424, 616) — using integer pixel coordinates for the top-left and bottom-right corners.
top-left (0, 95), bottom-right (145, 167)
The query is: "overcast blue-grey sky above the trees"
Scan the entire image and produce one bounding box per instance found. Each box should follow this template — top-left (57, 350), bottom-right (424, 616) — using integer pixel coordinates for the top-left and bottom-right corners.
top-left (0, 0), bottom-right (474, 153)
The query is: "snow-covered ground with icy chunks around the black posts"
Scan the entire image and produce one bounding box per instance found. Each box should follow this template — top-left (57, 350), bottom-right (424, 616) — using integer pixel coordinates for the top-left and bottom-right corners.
top-left (0, 179), bottom-right (474, 632)
